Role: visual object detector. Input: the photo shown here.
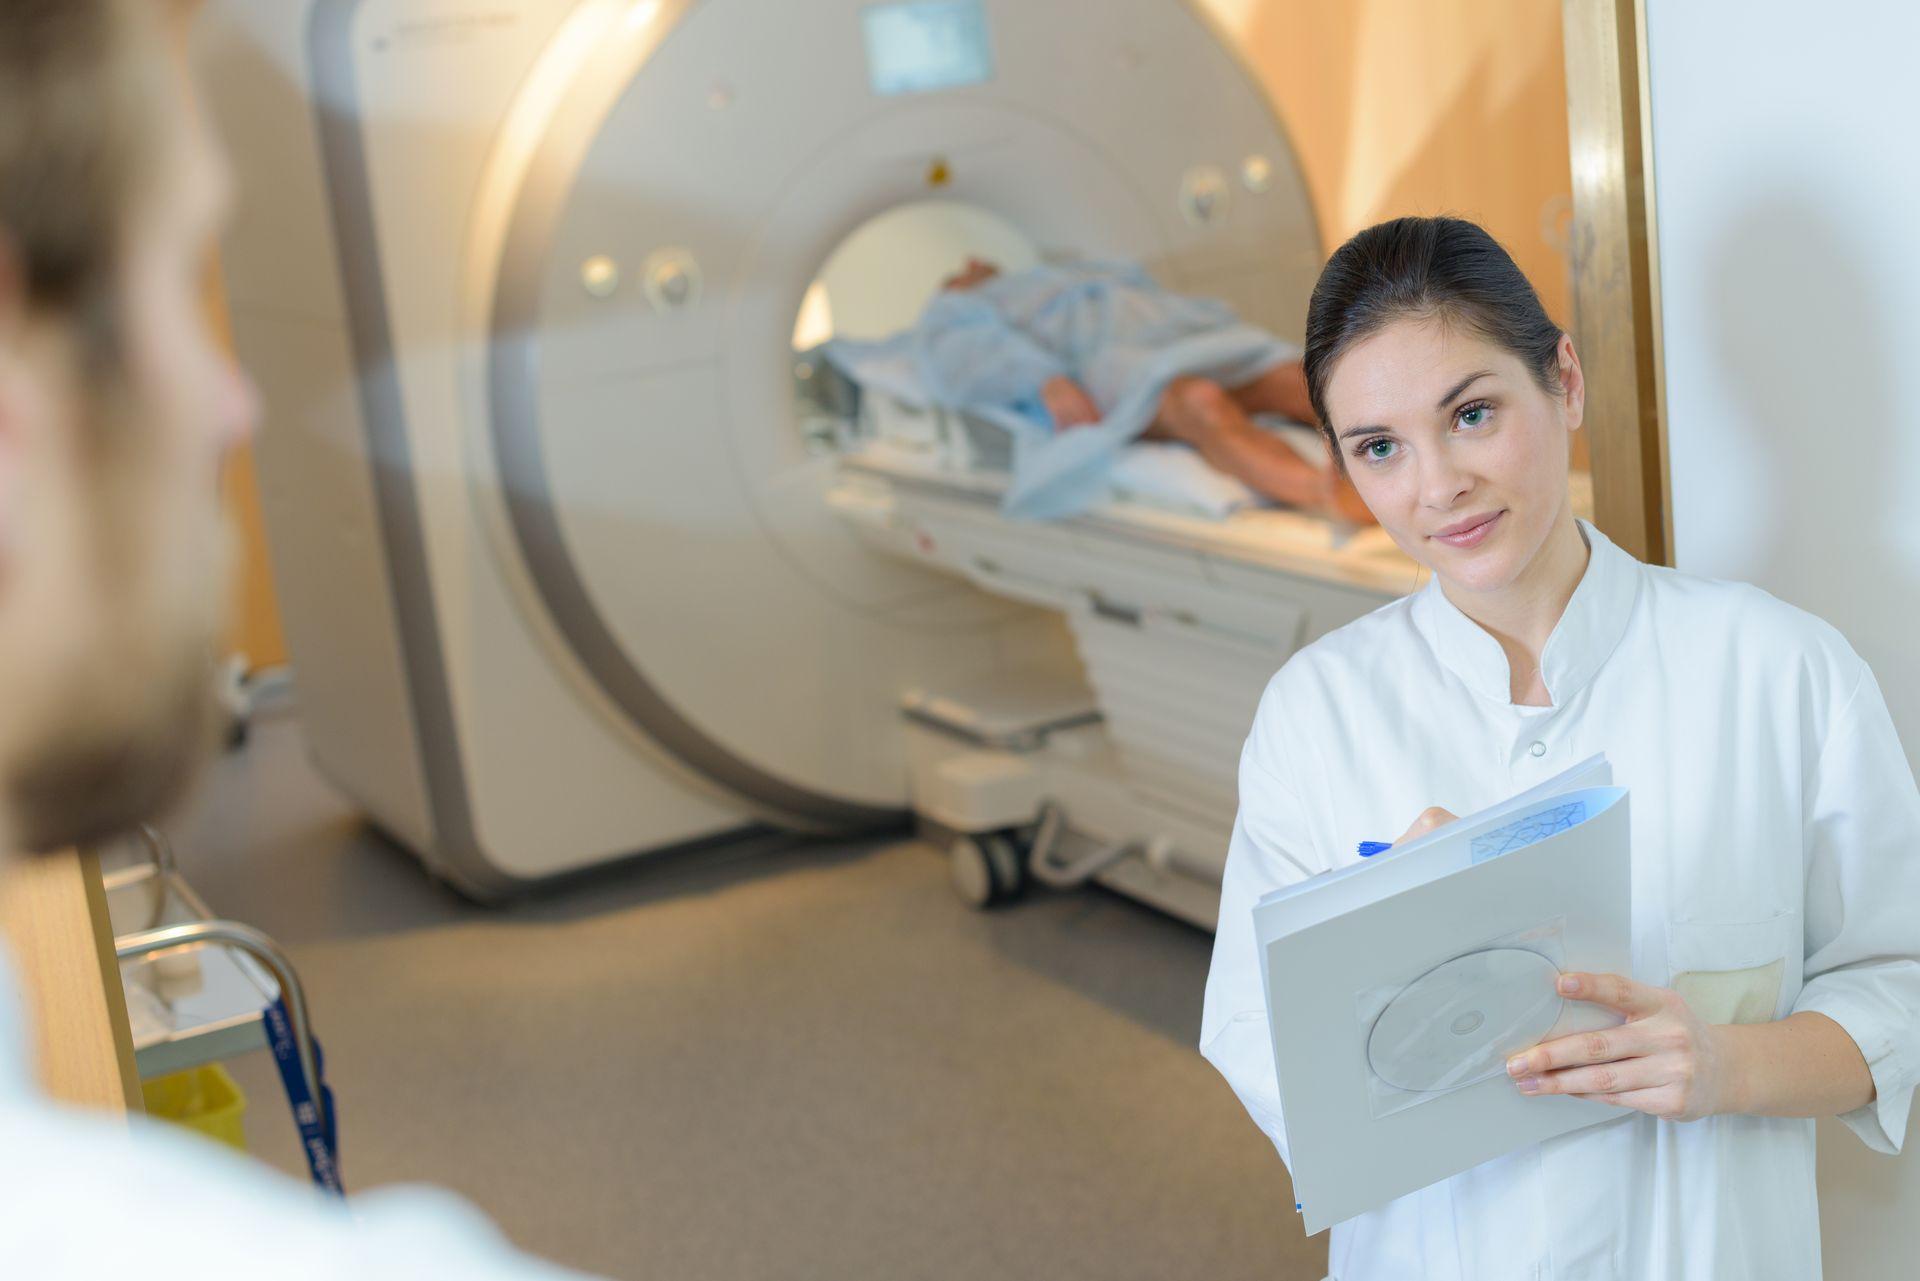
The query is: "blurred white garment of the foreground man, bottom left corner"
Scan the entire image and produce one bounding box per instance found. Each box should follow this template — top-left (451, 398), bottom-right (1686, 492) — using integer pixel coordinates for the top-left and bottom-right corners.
top-left (0, 937), bottom-right (599, 1281)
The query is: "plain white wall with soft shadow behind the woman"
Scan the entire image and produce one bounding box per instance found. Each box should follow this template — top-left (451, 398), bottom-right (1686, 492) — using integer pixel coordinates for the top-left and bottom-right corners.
top-left (1647, 0), bottom-right (1920, 1281)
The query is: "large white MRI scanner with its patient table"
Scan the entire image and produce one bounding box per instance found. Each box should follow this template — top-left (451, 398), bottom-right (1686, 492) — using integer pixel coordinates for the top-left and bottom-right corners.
top-left (196, 0), bottom-right (1417, 926)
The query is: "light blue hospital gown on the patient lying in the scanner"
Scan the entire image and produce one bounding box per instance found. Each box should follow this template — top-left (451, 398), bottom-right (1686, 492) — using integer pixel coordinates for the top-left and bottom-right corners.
top-left (826, 263), bottom-right (1298, 519)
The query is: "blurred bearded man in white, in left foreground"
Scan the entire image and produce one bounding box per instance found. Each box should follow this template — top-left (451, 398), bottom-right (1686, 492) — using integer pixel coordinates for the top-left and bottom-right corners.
top-left (0, 0), bottom-right (599, 1281)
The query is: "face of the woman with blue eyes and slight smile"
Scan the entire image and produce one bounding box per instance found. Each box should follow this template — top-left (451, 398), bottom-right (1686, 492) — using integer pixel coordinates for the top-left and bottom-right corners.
top-left (1325, 319), bottom-right (1584, 593)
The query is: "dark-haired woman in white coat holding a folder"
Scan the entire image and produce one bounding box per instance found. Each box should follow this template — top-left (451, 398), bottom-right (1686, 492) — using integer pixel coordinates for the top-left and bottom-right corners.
top-left (1200, 219), bottom-right (1920, 1281)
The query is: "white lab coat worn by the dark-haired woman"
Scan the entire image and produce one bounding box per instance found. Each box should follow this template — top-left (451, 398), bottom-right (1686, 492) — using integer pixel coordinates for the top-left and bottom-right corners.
top-left (1200, 520), bottom-right (1920, 1281)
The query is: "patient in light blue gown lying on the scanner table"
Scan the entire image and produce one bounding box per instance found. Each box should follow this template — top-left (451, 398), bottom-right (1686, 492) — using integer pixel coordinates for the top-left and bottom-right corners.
top-left (933, 257), bottom-right (1373, 522)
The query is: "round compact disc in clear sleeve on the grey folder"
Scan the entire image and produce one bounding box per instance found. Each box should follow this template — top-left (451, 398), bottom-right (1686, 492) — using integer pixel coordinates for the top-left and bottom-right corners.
top-left (1367, 947), bottom-right (1561, 1093)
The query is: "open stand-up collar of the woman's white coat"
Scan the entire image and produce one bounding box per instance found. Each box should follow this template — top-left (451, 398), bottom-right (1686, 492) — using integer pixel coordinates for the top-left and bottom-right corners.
top-left (1415, 520), bottom-right (1642, 707)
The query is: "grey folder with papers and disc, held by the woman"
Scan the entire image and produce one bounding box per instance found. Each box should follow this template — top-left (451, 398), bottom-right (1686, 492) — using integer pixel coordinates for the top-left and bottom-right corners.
top-left (1254, 757), bottom-right (1632, 1233)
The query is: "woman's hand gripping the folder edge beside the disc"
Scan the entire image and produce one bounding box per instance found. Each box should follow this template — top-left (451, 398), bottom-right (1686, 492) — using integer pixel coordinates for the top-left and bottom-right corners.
top-left (1507, 974), bottom-right (1734, 1122)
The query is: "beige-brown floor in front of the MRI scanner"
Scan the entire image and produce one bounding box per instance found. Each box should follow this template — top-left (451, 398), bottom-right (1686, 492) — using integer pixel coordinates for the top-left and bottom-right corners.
top-left (161, 720), bottom-right (1325, 1281)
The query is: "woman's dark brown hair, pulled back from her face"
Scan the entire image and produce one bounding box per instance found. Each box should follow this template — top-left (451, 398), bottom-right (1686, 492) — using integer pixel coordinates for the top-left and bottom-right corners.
top-left (1304, 217), bottom-right (1561, 459)
